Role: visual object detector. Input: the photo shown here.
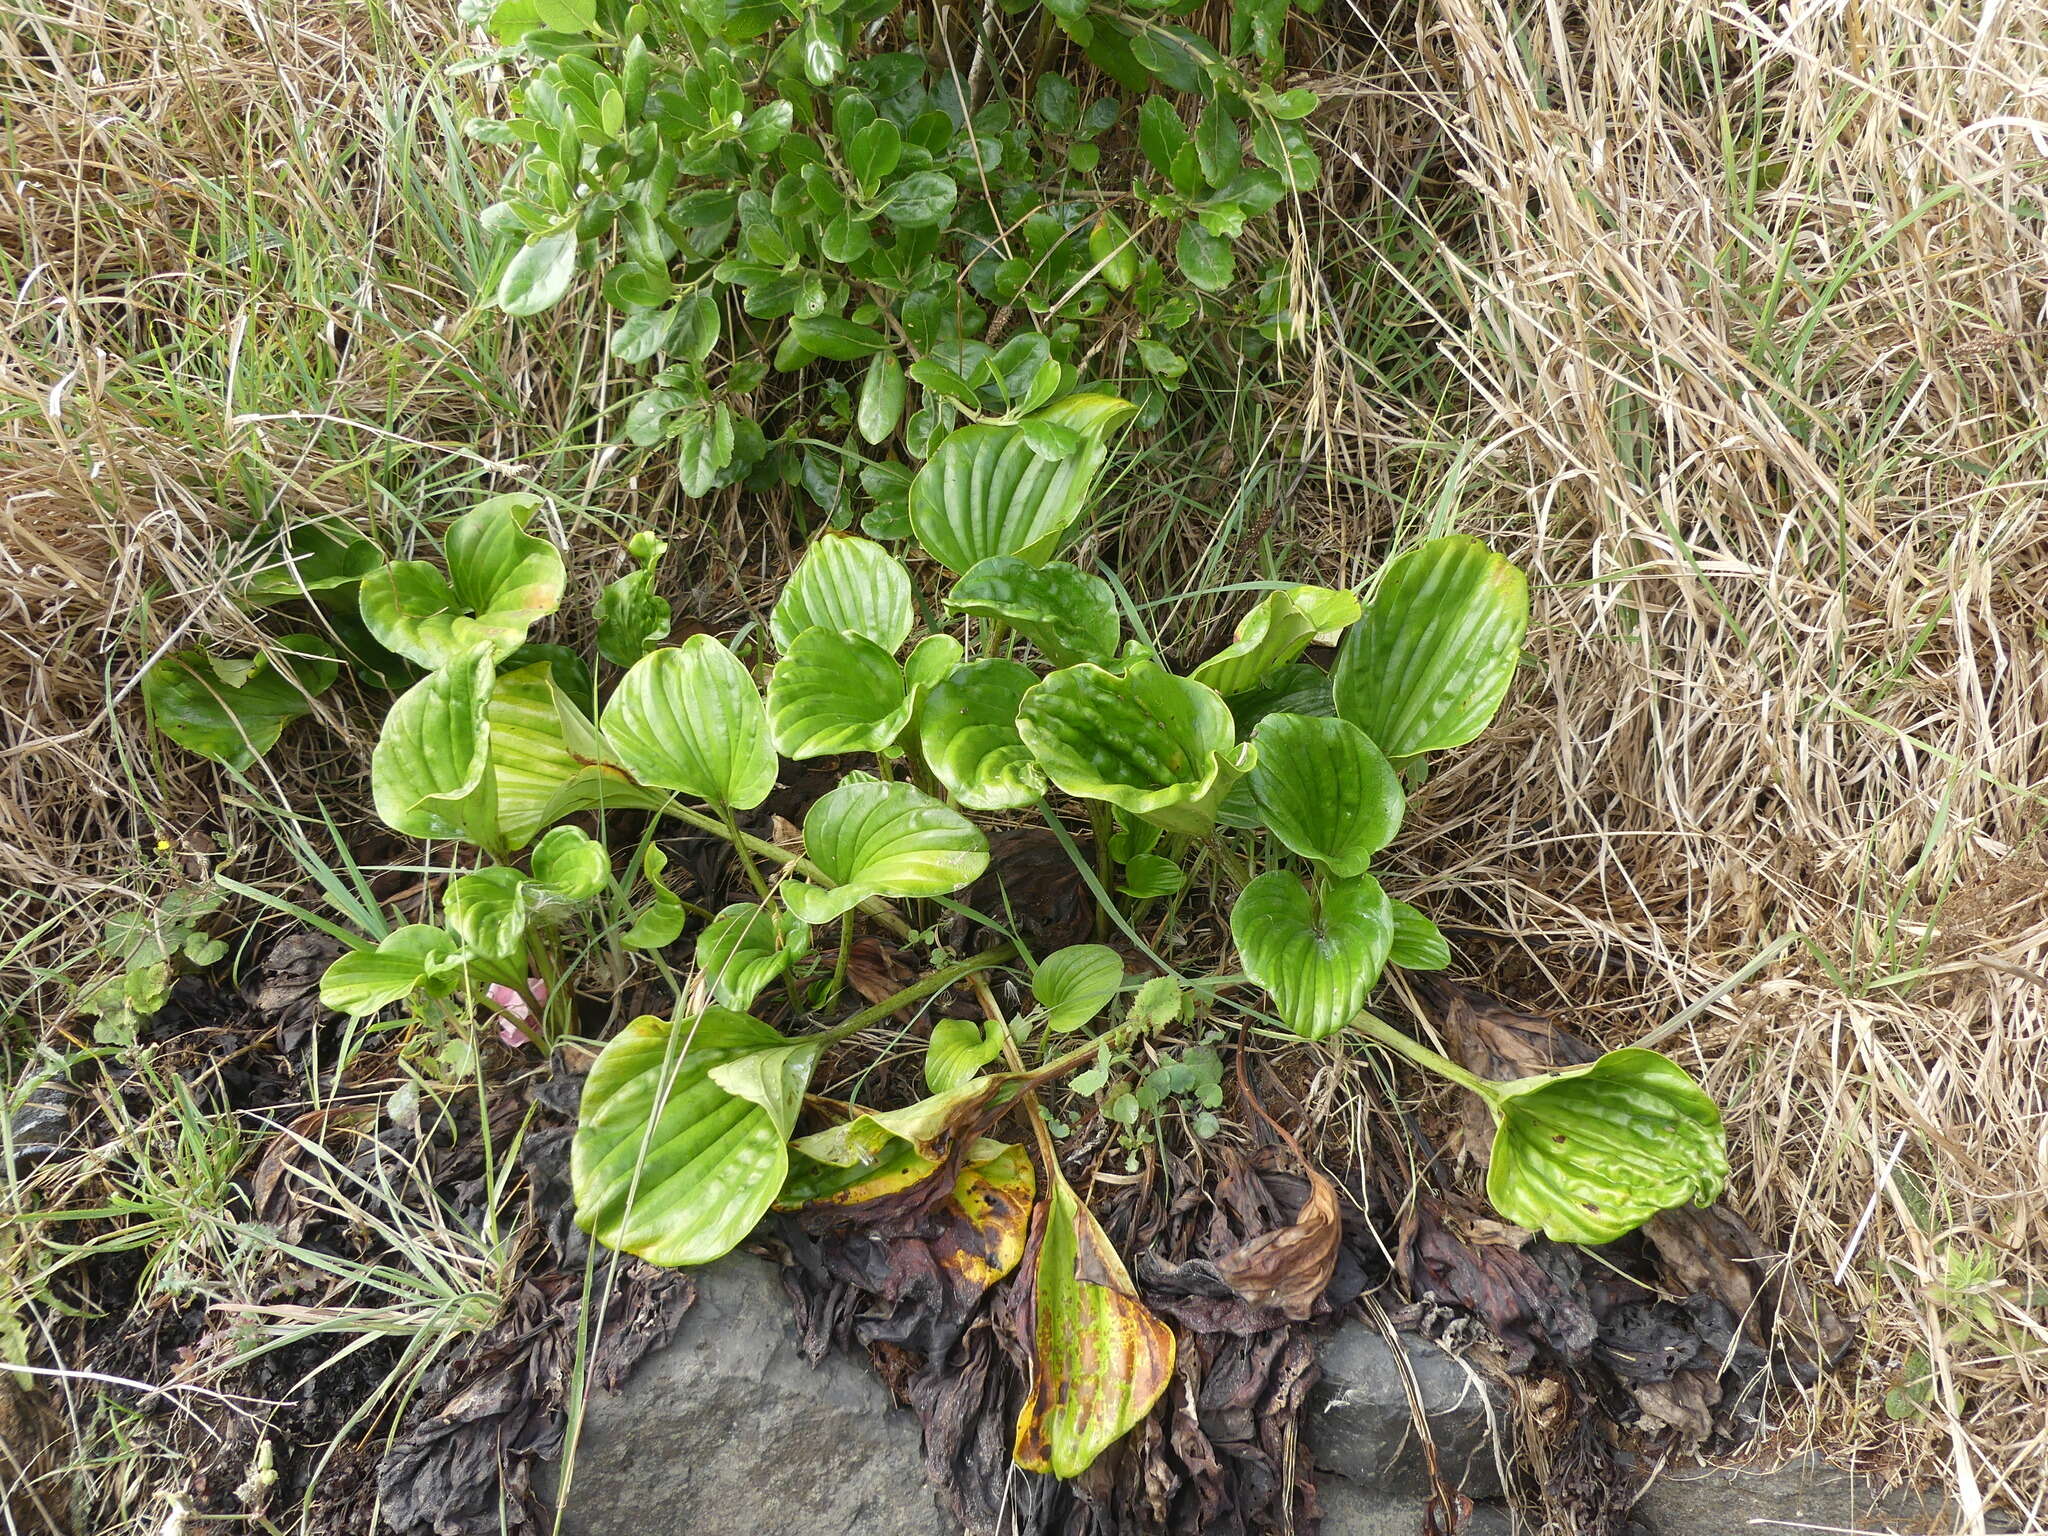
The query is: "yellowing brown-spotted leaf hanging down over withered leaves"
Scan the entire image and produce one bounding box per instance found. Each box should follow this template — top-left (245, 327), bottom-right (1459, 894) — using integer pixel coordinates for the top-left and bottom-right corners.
top-left (1012, 1167), bottom-right (1174, 1477)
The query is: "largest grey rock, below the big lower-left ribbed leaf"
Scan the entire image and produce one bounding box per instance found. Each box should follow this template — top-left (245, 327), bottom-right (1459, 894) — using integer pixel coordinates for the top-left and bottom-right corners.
top-left (543, 1255), bottom-right (954, 1536)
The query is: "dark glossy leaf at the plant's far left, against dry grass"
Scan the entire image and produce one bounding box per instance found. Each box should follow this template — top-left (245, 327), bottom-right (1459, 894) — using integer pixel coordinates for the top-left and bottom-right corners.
top-left (141, 635), bottom-right (340, 772)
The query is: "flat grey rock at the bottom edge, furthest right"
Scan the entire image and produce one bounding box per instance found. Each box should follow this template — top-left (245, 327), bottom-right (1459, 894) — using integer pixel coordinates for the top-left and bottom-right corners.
top-left (1634, 1456), bottom-right (2017, 1536)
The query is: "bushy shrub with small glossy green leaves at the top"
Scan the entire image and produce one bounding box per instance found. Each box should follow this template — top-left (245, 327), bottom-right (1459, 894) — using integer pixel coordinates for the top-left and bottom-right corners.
top-left (465, 0), bottom-right (1319, 518)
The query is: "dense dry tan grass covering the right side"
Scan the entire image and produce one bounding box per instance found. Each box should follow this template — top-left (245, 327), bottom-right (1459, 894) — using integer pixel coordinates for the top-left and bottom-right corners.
top-left (1303, 0), bottom-right (2048, 1530)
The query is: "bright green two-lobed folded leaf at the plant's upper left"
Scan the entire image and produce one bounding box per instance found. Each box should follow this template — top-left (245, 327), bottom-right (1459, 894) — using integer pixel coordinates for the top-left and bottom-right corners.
top-left (360, 496), bottom-right (565, 668)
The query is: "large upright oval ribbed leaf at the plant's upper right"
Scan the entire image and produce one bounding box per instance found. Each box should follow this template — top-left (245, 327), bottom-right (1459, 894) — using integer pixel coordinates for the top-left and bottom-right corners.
top-left (1333, 535), bottom-right (1530, 758)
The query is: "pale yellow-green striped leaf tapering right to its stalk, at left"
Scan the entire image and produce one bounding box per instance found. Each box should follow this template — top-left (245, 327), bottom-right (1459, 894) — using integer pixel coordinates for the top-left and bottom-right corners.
top-left (485, 662), bottom-right (668, 848)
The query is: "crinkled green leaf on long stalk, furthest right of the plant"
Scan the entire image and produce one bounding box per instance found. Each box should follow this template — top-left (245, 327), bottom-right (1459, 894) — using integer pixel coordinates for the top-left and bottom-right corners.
top-left (1487, 1047), bottom-right (1729, 1243)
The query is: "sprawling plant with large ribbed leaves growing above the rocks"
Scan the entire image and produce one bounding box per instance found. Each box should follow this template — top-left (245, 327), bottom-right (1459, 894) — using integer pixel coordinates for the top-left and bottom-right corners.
top-left (151, 378), bottom-right (1726, 1473)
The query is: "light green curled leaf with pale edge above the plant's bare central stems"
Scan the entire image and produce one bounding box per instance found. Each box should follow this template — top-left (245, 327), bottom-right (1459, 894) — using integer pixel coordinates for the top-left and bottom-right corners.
top-left (782, 778), bottom-right (989, 924)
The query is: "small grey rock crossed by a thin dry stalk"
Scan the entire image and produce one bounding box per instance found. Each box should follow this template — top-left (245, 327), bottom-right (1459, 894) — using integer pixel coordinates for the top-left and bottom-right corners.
top-left (1303, 1321), bottom-right (1503, 1499)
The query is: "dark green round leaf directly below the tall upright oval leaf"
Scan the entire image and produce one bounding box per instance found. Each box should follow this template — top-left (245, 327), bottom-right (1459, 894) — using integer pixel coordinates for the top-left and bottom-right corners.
top-left (1245, 715), bottom-right (1407, 879)
